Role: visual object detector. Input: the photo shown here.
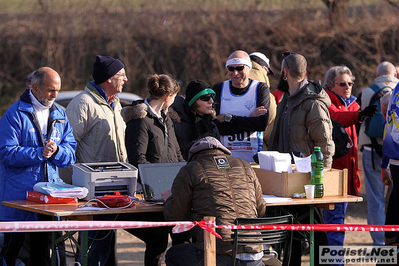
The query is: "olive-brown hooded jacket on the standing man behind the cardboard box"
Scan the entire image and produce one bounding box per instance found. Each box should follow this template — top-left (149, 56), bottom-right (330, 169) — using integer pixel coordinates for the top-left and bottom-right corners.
top-left (269, 80), bottom-right (335, 168)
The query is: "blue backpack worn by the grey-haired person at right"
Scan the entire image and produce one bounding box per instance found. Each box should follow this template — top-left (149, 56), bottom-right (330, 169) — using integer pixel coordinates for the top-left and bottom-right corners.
top-left (364, 84), bottom-right (392, 139)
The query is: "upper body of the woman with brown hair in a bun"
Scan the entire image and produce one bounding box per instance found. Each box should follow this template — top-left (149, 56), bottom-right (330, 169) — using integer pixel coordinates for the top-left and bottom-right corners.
top-left (122, 74), bottom-right (184, 167)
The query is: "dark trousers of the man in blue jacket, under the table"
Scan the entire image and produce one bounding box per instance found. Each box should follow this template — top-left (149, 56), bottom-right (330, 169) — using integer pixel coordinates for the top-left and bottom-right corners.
top-left (0, 216), bottom-right (66, 266)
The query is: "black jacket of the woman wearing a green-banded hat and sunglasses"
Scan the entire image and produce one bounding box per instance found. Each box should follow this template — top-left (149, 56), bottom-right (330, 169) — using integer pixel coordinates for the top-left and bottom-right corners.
top-left (168, 96), bottom-right (220, 160)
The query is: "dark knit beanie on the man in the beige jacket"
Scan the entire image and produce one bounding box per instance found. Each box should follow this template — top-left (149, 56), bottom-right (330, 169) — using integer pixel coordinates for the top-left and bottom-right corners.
top-left (93, 55), bottom-right (125, 84)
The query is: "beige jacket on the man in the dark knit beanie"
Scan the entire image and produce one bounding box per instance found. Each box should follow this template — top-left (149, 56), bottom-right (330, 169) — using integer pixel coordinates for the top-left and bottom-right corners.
top-left (66, 82), bottom-right (127, 163)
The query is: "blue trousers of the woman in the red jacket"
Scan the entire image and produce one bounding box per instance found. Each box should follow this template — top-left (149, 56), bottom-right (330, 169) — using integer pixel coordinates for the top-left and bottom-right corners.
top-left (324, 202), bottom-right (348, 266)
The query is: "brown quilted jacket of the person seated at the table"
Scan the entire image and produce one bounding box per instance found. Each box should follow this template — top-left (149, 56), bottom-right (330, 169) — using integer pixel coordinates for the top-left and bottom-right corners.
top-left (164, 143), bottom-right (266, 254)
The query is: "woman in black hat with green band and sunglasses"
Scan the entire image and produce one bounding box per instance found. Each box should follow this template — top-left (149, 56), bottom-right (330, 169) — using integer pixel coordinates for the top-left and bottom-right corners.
top-left (170, 80), bottom-right (220, 160)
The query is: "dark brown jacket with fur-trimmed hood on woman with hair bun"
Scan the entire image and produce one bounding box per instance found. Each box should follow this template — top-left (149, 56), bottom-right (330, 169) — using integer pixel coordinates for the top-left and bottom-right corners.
top-left (122, 100), bottom-right (184, 167)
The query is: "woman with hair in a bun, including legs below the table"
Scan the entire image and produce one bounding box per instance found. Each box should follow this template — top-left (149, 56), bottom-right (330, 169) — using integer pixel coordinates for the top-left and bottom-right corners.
top-left (118, 74), bottom-right (184, 266)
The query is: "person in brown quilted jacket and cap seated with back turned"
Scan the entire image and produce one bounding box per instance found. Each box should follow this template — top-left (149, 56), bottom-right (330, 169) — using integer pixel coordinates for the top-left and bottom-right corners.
top-left (163, 137), bottom-right (266, 266)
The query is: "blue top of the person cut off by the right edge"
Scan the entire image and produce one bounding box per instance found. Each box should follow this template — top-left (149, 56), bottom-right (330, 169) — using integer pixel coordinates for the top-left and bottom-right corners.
top-left (382, 84), bottom-right (399, 160)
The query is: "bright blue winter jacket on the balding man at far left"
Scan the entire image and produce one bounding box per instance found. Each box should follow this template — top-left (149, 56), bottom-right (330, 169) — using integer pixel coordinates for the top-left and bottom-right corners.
top-left (0, 89), bottom-right (76, 221)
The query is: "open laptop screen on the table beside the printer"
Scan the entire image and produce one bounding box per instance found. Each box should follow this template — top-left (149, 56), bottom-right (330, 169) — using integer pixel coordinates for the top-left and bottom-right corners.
top-left (138, 162), bottom-right (186, 202)
